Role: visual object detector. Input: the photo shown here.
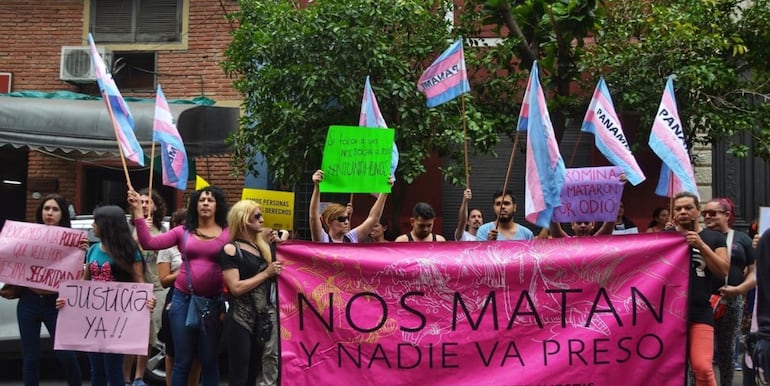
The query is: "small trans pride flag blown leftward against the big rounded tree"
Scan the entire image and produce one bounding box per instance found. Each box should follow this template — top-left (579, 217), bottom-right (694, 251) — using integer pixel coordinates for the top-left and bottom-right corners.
top-left (417, 38), bottom-right (471, 107)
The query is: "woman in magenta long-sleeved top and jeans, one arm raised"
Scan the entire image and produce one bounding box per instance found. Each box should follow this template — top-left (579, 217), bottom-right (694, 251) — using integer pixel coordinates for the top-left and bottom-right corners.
top-left (128, 186), bottom-right (229, 386)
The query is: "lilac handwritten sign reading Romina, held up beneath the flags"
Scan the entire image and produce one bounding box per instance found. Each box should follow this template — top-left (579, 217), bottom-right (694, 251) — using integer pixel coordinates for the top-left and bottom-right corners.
top-left (552, 166), bottom-right (623, 222)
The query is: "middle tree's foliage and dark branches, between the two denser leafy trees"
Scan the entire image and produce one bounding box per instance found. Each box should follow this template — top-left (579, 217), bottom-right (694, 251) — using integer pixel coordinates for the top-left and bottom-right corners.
top-left (457, 0), bottom-right (603, 140)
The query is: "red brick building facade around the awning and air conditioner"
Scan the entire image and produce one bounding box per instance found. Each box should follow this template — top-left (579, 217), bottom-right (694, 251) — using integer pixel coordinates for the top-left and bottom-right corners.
top-left (0, 0), bottom-right (243, 221)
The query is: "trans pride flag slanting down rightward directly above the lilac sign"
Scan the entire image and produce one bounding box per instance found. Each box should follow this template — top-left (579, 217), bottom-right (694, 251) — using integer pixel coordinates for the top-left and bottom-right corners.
top-left (581, 77), bottom-right (646, 185)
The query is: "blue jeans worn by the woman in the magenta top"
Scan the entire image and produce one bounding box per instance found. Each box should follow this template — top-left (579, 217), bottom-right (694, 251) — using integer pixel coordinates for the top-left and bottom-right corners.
top-left (168, 290), bottom-right (222, 386)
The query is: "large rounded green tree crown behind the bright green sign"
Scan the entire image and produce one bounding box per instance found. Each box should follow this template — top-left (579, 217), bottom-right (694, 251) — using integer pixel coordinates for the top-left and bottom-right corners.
top-left (223, 0), bottom-right (499, 186)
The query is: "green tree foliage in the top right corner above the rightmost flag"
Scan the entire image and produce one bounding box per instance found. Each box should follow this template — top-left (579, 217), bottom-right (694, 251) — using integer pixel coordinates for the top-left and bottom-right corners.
top-left (582, 0), bottom-right (770, 160)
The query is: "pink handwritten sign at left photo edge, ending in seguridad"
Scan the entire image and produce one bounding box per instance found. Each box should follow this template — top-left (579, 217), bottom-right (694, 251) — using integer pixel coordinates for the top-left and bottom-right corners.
top-left (0, 220), bottom-right (86, 291)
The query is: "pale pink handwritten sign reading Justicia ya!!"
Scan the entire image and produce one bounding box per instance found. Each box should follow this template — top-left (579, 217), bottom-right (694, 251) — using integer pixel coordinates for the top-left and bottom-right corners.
top-left (53, 280), bottom-right (152, 355)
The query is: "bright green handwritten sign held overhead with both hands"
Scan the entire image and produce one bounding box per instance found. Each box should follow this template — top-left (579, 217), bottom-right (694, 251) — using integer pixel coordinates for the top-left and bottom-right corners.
top-left (319, 126), bottom-right (394, 193)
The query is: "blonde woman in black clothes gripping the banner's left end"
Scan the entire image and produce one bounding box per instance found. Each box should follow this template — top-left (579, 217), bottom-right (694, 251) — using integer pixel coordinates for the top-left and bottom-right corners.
top-left (219, 200), bottom-right (281, 385)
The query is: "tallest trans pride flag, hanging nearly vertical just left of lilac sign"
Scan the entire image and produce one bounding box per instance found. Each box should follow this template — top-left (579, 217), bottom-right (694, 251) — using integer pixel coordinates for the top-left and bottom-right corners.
top-left (518, 62), bottom-right (566, 227)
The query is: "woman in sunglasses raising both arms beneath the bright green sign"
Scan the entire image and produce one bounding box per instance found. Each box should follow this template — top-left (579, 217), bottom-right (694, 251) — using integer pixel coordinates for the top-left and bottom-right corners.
top-left (310, 170), bottom-right (393, 243)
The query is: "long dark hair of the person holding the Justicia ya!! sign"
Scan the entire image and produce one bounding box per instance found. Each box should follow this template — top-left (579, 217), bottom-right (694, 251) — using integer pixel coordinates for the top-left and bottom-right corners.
top-left (94, 205), bottom-right (139, 281)
